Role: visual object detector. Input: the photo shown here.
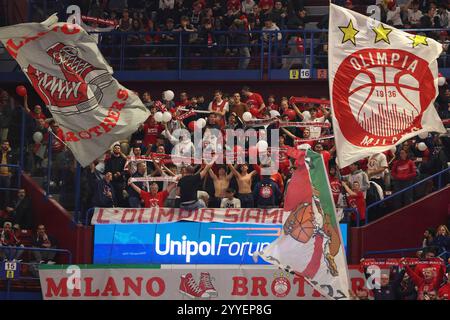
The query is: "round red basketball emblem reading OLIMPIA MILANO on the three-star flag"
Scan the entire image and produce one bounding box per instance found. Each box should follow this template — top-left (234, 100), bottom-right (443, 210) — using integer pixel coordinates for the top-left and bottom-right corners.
top-left (333, 49), bottom-right (436, 146)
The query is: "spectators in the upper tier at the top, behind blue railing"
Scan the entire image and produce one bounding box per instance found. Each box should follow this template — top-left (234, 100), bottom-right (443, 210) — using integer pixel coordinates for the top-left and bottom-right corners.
top-left (22, 0), bottom-right (449, 69)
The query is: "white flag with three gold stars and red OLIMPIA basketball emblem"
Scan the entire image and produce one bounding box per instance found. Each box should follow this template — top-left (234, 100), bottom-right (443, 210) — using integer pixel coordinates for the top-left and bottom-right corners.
top-left (328, 4), bottom-right (445, 168)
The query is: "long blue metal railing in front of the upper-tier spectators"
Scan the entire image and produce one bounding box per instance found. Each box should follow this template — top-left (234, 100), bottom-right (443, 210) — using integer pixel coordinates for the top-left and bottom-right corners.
top-left (2, 29), bottom-right (450, 80)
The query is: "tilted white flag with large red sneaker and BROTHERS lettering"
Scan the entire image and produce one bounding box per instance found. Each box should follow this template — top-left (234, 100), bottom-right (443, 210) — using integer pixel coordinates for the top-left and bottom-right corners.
top-left (0, 15), bottom-right (150, 166)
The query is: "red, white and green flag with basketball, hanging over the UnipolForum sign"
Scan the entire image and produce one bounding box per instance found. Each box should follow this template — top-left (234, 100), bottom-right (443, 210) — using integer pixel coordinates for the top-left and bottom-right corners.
top-left (259, 150), bottom-right (349, 300)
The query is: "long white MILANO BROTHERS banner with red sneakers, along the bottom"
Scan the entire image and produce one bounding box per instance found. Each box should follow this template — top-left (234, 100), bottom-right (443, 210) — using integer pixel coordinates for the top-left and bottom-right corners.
top-left (39, 265), bottom-right (366, 301)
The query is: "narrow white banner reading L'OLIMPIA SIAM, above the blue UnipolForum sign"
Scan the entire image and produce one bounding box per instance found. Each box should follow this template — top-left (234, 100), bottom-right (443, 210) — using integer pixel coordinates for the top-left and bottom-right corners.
top-left (91, 207), bottom-right (290, 225)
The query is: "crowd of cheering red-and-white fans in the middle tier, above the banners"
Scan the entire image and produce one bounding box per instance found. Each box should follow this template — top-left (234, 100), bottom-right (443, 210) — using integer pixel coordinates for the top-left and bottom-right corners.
top-left (0, 81), bottom-right (450, 227)
